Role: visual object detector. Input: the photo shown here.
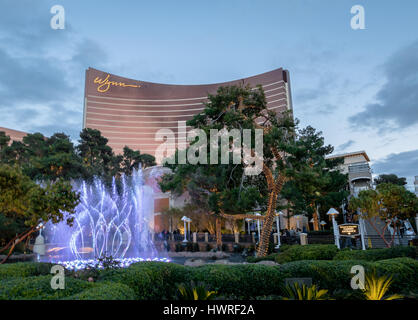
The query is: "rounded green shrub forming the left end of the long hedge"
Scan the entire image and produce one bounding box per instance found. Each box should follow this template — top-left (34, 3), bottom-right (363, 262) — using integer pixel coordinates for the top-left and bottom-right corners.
top-left (99, 262), bottom-right (187, 300)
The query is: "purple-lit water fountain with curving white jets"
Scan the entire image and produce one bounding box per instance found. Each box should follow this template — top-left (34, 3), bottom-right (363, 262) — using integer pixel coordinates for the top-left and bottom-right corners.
top-left (43, 170), bottom-right (168, 269)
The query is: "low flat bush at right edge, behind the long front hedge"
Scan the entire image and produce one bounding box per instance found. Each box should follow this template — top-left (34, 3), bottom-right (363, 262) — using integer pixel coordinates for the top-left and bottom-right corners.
top-left (334, 247), bottom-right (417, 261)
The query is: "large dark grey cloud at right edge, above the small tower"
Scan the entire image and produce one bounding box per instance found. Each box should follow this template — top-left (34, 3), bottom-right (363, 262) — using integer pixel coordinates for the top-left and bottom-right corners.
top-left (349, 41), bottom-right (418, 132)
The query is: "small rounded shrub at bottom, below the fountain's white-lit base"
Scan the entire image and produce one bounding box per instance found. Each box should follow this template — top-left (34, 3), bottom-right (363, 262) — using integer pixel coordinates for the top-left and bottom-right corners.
top-left (65, 282), bottom-right (136, 300)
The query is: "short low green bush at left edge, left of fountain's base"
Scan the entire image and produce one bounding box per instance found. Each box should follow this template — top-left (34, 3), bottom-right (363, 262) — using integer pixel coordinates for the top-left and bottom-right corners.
top-left (0, 262), bottom-right (53, 280)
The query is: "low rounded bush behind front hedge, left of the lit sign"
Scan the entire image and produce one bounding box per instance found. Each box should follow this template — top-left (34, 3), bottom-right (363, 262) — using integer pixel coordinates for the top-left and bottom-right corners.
top-left (276, 244), bottom-right (338, 264)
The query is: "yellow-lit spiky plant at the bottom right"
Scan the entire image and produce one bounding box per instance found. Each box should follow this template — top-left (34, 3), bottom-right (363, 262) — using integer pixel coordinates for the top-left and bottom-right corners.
top-left (363, 271), bottom-right (402, 300)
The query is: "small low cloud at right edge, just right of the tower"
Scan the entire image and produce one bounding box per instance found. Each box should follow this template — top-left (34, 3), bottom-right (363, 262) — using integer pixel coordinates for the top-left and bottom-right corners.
top-left (372, 149), bottom-right (418, 186)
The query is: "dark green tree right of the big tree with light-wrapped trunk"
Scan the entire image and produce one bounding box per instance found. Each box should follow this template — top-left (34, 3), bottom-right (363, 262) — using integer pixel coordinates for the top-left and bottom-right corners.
top-left (282, 126), bottom-right (349, 230)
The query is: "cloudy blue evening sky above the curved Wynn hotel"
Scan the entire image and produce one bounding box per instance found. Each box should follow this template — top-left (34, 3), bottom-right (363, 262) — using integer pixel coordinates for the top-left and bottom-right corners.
top-left (0, 0), bottom-right (418, 187)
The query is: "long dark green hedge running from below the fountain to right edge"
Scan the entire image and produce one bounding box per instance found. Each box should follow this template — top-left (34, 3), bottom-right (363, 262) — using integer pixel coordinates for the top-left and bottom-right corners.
top-left (97, 258), bottom-right (418, 300)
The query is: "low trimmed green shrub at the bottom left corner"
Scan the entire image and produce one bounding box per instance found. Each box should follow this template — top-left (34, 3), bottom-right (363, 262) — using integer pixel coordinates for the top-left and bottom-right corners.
top-left (0, 275), bottom-right (92, 300)
